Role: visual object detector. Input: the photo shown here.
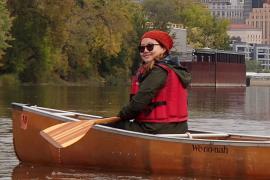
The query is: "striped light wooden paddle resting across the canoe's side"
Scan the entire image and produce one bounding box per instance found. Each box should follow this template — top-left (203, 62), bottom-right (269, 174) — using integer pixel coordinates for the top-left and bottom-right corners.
top-left (40, 117), bottom-right (120, 148)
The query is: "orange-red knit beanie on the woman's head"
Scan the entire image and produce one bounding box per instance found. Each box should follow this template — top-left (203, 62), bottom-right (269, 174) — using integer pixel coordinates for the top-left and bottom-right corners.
top-left (141, 30), bottom-right (173, 51)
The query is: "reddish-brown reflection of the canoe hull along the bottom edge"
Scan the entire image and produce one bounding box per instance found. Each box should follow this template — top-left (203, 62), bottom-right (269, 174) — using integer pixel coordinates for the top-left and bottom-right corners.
top-left (12, 163), bottom-right (230, 180)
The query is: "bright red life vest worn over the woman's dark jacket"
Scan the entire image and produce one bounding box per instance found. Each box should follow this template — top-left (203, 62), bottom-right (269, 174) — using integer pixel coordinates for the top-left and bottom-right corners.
top-left (131, 64), bottom-right (188, 123)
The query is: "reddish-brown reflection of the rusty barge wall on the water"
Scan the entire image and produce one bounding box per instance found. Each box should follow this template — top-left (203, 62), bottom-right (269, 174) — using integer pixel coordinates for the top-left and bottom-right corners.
top-left (189, 87), bottom-right (246, 118)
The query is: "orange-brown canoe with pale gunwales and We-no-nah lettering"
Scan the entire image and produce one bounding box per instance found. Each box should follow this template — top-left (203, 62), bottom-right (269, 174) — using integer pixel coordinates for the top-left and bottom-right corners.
top-left (12, 103), bottom-right (270, 178)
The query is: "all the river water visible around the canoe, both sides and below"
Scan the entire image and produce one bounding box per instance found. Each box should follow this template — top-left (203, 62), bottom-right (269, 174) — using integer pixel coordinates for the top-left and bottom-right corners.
top-left (0, 85), bottom-right (270, 179)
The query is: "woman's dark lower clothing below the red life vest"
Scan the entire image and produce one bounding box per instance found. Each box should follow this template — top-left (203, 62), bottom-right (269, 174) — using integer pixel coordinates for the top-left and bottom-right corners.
top-left (109, 121), bottom-right (188, 134)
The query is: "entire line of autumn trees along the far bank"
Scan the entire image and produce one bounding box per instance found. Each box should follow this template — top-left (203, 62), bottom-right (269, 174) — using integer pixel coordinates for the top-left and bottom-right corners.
top-left (0, 0), bottom-right (229, 83)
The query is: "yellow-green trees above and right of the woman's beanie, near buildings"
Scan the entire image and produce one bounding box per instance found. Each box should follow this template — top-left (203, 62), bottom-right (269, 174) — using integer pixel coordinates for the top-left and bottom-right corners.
top-left (143, 0), bottom-right (229, 49)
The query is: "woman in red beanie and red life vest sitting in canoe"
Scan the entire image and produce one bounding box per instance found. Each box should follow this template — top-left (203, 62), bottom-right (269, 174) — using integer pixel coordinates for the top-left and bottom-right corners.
top-left (113, 30), bottom-right (191, 134)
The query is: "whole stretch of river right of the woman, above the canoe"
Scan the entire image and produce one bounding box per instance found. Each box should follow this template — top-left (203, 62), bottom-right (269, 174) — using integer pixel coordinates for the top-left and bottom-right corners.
top-left (189, 87), bottom-right (270, 135)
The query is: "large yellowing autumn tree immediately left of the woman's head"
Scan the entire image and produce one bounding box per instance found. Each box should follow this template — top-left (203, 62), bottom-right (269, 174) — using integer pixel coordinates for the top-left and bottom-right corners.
top-left (60, 0), bottom-right (142, 81)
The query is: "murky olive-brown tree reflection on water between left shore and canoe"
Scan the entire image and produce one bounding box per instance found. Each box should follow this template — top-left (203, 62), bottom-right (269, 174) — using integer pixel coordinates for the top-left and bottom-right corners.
top-left (0, 86), bottom-right (129, 117)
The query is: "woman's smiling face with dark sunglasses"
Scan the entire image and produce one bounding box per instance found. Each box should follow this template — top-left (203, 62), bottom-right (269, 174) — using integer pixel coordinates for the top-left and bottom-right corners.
top-left (139, 38), bottom-right (166, 63)
